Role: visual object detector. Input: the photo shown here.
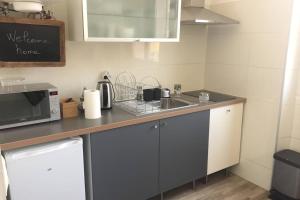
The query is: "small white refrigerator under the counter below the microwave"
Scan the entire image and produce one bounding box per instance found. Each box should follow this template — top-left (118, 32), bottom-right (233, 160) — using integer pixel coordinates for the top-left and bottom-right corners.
top-left (4, 138), bottom-right (85, 200)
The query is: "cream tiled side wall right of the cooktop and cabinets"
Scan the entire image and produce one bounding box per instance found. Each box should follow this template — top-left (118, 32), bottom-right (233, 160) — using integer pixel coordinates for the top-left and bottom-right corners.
top-left (205, 0), bottom-right (292, 189)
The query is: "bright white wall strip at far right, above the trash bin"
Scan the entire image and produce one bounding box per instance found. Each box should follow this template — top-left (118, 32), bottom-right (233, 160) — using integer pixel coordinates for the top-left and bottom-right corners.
top-left (278, 0), bottom-right (300, 152)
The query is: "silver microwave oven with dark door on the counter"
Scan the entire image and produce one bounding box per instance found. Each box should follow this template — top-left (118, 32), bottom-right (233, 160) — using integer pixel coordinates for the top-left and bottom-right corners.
top-left (0, 83), bottom-right (60, 129)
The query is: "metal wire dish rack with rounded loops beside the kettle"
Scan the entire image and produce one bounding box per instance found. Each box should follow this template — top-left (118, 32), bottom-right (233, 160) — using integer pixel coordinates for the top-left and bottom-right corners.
top-left (114, 72), bottom-right (161, 102)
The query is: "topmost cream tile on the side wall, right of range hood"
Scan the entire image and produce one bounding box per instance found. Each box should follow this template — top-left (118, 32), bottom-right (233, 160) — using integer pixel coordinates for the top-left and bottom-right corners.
top-left (210, 0), bottom-right (292, 34)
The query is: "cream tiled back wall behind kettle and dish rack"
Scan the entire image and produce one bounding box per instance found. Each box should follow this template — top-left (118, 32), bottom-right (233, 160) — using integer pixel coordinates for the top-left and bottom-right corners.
top-left (0, 0), bottom-right (207, 97)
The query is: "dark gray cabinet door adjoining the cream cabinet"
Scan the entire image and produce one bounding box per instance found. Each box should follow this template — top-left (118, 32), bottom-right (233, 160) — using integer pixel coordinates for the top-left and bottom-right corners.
top-left (160, 111), bottom-right (209, 192)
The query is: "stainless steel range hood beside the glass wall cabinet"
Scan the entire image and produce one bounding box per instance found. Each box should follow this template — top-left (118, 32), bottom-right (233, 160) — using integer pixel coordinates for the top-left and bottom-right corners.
top-left (181, 0), bottom-right (239, 25)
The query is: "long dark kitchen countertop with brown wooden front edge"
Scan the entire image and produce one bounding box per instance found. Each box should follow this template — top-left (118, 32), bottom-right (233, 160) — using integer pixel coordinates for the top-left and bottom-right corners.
top-left (0, 95), bottom-right (246, 150)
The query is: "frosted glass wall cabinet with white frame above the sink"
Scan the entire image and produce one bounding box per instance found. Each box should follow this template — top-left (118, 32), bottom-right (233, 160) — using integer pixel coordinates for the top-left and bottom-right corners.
top-left (84, 0), bottom-right (181, 41)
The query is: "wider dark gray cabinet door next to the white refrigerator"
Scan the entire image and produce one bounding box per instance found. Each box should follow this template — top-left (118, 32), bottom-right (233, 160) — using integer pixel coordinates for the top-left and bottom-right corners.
top-left (91, 122), bottom-right (159, 200)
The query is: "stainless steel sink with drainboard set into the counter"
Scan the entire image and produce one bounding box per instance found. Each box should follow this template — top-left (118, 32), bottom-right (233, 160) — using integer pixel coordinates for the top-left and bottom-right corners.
top-left (115, 98), bottom-right (198, 116)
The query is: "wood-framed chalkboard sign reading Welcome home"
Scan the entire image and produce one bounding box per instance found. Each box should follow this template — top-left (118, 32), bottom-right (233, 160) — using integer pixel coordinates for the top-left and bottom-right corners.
top-left (0, 17), bottom-right (65, 67)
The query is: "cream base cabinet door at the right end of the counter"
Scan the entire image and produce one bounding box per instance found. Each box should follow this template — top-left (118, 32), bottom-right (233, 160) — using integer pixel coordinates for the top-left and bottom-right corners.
top-left (207, 103), bottom-right (243, 175)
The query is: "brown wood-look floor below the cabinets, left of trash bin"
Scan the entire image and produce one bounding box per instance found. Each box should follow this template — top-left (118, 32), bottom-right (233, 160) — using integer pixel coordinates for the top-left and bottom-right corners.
top-left (152, 173), bottom-right (268, 200)
